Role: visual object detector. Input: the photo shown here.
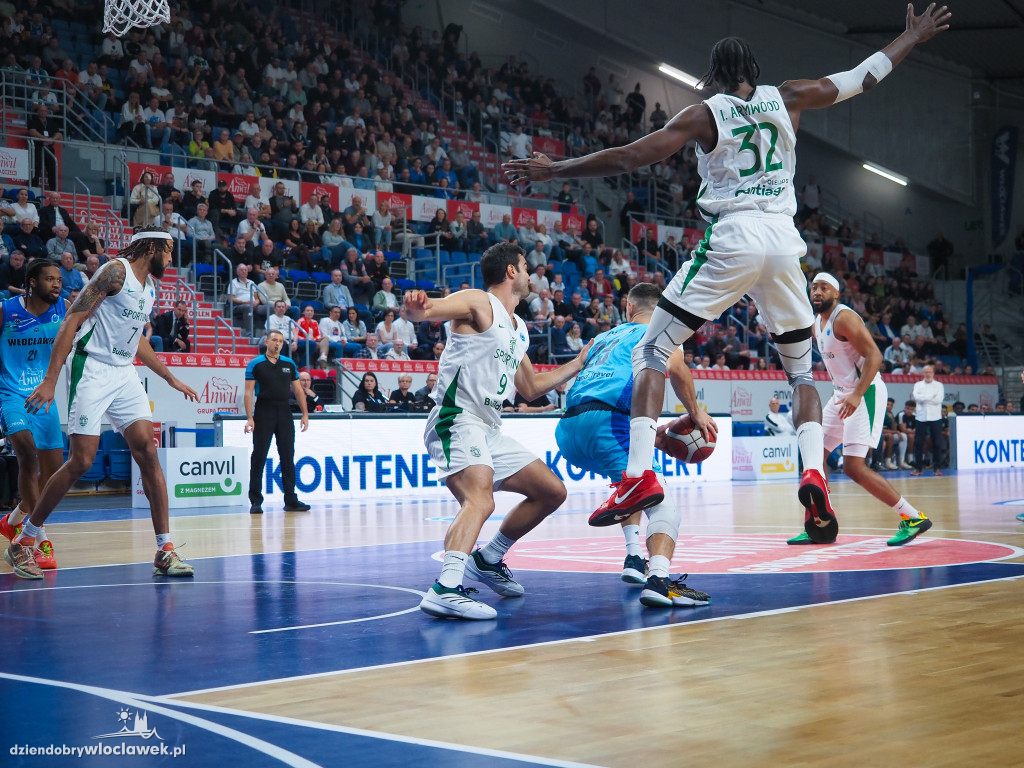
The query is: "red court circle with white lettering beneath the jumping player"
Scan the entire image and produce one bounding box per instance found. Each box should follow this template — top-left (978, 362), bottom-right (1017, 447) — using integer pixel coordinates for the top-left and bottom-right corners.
top-left (505, 534), bottom-right (1024, 573)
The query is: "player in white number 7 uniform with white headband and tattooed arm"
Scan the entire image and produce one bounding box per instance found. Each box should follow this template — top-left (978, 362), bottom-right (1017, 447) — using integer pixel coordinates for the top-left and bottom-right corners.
top-left (7, 227), bottom-right (198, 579)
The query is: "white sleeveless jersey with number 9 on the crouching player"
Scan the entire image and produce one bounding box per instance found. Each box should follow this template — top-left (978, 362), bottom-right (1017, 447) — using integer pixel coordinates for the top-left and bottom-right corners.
top-left (430, 293), bottom-right (529, 426)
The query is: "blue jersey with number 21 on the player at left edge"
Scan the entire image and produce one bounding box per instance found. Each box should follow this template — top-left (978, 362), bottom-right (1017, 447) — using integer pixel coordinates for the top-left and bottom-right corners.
top-left (0, 296), bottom-right (67, 397)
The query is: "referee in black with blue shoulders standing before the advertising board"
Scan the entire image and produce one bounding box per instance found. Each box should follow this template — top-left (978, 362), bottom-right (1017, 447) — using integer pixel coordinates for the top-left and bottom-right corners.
top-left (246, 331), bottom-right (309, 515)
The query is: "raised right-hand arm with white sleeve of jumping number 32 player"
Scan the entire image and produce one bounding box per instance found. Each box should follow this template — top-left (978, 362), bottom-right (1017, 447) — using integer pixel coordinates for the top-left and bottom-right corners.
top-left (779, 3), bottom-right (952, 116)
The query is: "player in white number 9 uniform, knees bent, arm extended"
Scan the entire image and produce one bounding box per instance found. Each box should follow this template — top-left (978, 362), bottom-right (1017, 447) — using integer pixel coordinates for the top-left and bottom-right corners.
top-left (404, 243), bottom-right (590, 620)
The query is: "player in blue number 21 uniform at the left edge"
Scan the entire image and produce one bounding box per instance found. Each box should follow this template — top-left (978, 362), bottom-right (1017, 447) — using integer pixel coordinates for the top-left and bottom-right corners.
top-left (0, 259), bottom-right (68, 575)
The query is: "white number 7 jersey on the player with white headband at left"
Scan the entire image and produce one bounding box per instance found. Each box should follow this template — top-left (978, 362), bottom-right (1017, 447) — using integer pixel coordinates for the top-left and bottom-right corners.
top-left (75, 258), bottom-right (157, 366)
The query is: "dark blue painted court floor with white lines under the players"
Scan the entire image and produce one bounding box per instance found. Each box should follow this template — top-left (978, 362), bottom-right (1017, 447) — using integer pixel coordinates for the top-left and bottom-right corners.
top-left (0, 542), bottom-right (1024, 768)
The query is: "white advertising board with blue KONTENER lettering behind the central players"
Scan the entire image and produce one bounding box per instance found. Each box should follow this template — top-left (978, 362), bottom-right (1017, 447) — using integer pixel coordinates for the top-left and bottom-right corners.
top-left (219, 416), bottom-right (732, 501)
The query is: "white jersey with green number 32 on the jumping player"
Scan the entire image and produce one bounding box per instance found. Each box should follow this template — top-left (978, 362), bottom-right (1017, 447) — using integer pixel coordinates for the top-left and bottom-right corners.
top-left (696, 85), bottom-right (797, 222)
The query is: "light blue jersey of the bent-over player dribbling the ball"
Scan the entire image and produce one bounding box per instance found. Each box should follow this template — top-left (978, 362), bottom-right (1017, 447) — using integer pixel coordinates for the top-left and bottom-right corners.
top-left (565, 323), bottom-right (647, 414)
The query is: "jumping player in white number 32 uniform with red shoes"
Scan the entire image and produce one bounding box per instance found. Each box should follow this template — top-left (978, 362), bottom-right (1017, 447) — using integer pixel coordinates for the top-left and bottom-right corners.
top-left (503, 3), bottom-right (950, 540)
